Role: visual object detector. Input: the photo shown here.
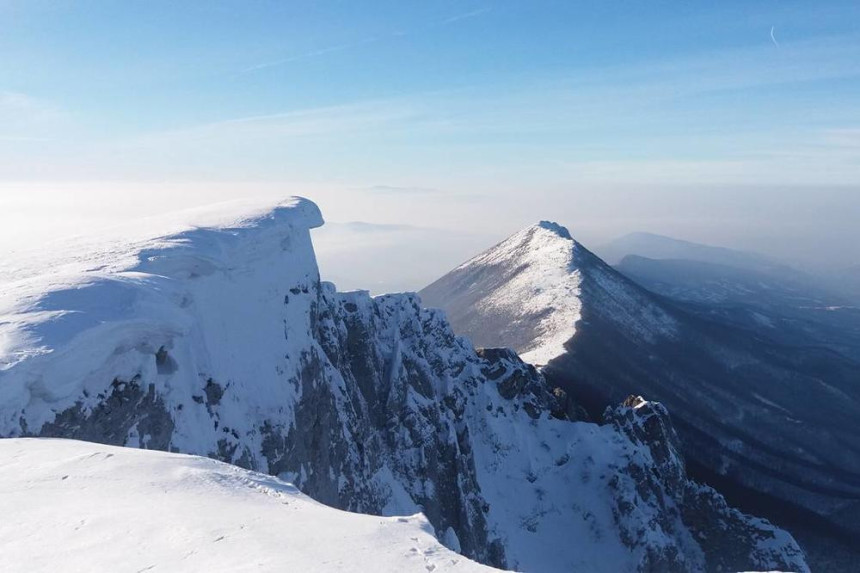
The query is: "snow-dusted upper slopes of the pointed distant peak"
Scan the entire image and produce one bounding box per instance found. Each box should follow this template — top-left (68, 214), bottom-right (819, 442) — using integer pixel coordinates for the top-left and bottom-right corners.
top-left (421, 221), bottom-right (677, 366)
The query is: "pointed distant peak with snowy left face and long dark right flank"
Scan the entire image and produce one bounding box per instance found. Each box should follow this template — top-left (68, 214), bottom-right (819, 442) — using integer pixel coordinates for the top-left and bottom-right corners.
top-left (421, 223), bottom-right (860, 556)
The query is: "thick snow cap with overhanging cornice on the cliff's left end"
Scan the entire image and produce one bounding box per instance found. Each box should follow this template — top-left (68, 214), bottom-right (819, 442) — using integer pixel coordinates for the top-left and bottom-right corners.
top-left (0, 198), bottom-right (323, 454)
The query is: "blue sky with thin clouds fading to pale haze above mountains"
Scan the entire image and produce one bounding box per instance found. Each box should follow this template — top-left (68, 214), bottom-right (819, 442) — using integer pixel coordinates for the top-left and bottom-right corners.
top-left (0, 0), bottom-right (860, 280)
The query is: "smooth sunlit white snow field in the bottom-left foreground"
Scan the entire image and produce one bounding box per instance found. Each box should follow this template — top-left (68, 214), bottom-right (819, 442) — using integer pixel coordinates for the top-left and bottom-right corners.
top-left (0, 438), bottom-right (492, 573)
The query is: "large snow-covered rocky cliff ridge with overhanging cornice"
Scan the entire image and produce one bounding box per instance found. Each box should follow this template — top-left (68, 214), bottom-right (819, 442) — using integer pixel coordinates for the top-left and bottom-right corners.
top-left (0, 200), bottom-right (807, 572)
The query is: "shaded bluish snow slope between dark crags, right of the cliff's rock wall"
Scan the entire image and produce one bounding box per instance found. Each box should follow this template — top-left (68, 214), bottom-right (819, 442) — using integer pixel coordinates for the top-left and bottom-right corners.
top-left (472, 378), bottom-right (698, 573)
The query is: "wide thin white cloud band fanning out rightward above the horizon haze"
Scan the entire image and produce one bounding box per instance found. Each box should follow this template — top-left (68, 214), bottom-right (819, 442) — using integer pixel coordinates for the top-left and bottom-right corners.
top-left (8, 33), bottom-right (860, 188)
